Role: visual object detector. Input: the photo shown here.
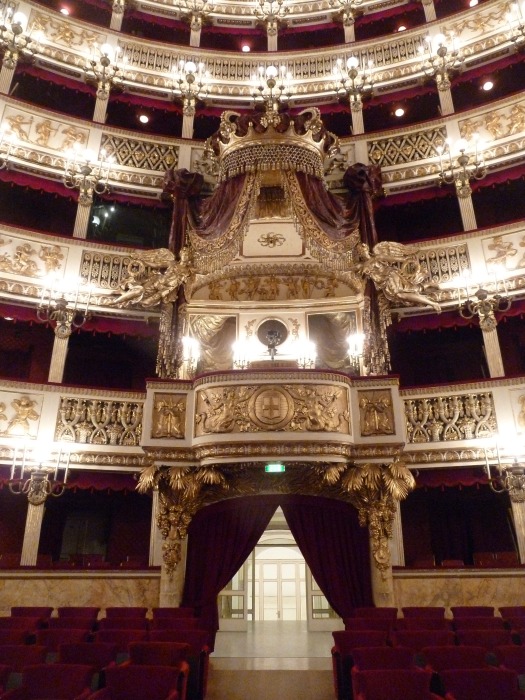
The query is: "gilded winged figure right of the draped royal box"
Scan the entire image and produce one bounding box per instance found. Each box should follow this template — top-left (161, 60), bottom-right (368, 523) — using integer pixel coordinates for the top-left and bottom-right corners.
top-left (356, 241), bottom-right (441, 313)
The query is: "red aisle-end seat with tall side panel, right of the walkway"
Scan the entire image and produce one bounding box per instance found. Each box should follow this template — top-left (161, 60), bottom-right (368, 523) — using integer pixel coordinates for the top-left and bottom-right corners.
top-left (332, 630), bottom-right (388, 700)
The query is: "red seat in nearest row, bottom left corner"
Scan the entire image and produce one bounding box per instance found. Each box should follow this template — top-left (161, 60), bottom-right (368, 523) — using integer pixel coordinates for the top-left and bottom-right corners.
top-left (2, 664), bottom-right (93, 700)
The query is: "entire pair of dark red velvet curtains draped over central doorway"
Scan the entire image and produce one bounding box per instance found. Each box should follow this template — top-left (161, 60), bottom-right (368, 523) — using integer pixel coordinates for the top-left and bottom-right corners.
top-left (182, 495), bottom-right (373, 632)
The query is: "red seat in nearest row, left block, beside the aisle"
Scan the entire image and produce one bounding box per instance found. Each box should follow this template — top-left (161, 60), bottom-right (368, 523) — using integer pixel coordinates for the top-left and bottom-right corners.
top-left (90, 666), bottom-right (185, 700)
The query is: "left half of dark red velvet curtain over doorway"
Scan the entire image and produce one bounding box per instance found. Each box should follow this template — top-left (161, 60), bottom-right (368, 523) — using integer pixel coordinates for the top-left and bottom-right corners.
top-left (182, 497), bottom-right (277, 633)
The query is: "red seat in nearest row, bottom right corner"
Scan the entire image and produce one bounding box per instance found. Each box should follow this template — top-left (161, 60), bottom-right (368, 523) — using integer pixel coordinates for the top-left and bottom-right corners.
top-left (440, 668), bottom-right (523, 700)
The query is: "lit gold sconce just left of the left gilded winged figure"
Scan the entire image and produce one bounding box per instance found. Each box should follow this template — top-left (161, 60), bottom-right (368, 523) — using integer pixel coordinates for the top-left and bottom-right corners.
top-left (36, 278), bottom-right (92, 339)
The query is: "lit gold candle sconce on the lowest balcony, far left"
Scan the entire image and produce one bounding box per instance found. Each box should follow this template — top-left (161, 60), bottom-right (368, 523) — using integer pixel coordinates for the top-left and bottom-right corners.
top-left (8, 443), bottom-right (71, 506)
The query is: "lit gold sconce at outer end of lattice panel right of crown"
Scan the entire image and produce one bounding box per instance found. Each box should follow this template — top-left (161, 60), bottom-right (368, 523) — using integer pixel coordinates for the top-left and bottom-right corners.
top-left (437, 134), bottom-right (487, 197)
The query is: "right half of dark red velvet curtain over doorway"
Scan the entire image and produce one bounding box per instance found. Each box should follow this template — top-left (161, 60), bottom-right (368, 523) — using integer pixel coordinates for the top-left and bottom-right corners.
top-left (281, 496), bottom-right (373, 617)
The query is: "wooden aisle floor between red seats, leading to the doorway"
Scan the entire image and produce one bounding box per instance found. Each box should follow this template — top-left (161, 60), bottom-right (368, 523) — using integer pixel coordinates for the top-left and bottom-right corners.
top-left (206, 621), bottom-right (337, 700)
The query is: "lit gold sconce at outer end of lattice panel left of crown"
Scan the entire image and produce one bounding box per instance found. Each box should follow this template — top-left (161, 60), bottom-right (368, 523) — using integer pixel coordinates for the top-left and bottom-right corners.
top-left (62, 149), bottom-right (113, 206)
